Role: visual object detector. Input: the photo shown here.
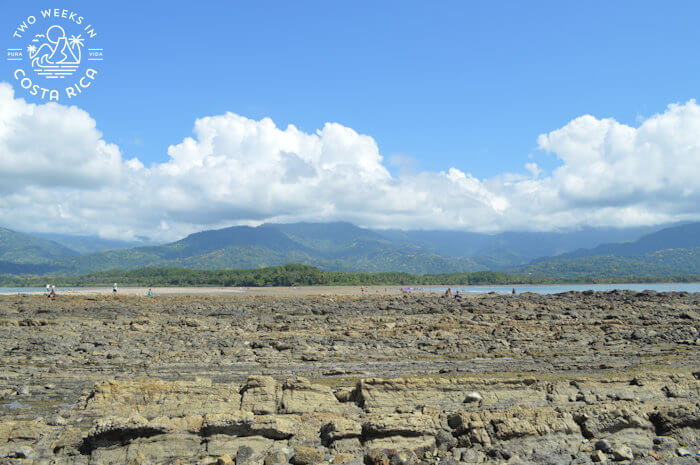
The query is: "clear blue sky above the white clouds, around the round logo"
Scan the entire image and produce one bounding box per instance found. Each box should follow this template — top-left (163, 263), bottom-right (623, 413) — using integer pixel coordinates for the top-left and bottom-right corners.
top-left (0, 0), bottom-right (700, 177)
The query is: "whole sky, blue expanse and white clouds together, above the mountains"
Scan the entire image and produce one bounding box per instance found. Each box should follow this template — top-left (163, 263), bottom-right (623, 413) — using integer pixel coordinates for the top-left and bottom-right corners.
top-left (0, 0), bottom-right (700, 237)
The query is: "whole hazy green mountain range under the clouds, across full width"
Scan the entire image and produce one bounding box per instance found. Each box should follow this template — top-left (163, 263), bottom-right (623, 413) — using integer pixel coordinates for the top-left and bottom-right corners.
top-left (0, 222), bottom-right (700, 277)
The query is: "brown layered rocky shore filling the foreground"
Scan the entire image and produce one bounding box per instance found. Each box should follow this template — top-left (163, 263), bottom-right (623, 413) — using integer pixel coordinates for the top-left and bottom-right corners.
top-left (0, 291), bottom-right (700, 465)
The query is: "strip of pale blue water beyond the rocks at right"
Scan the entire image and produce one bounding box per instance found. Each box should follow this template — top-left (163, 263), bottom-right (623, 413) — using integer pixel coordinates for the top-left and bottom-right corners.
top-left (423, 283), bottom-right (700, 294)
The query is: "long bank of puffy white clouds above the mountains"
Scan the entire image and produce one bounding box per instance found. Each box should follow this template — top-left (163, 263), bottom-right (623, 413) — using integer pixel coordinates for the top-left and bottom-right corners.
top-left (0, 83), bottom-right (700, 240)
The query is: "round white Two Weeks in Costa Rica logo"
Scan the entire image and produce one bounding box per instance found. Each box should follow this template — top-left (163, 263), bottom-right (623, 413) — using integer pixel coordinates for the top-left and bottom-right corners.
top-left (7, 8), bottom-right (104, 101)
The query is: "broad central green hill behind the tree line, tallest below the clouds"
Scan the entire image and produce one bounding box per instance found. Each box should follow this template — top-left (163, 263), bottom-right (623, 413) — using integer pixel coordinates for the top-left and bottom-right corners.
top-left (0, 223), bottom-right (485, 275)
